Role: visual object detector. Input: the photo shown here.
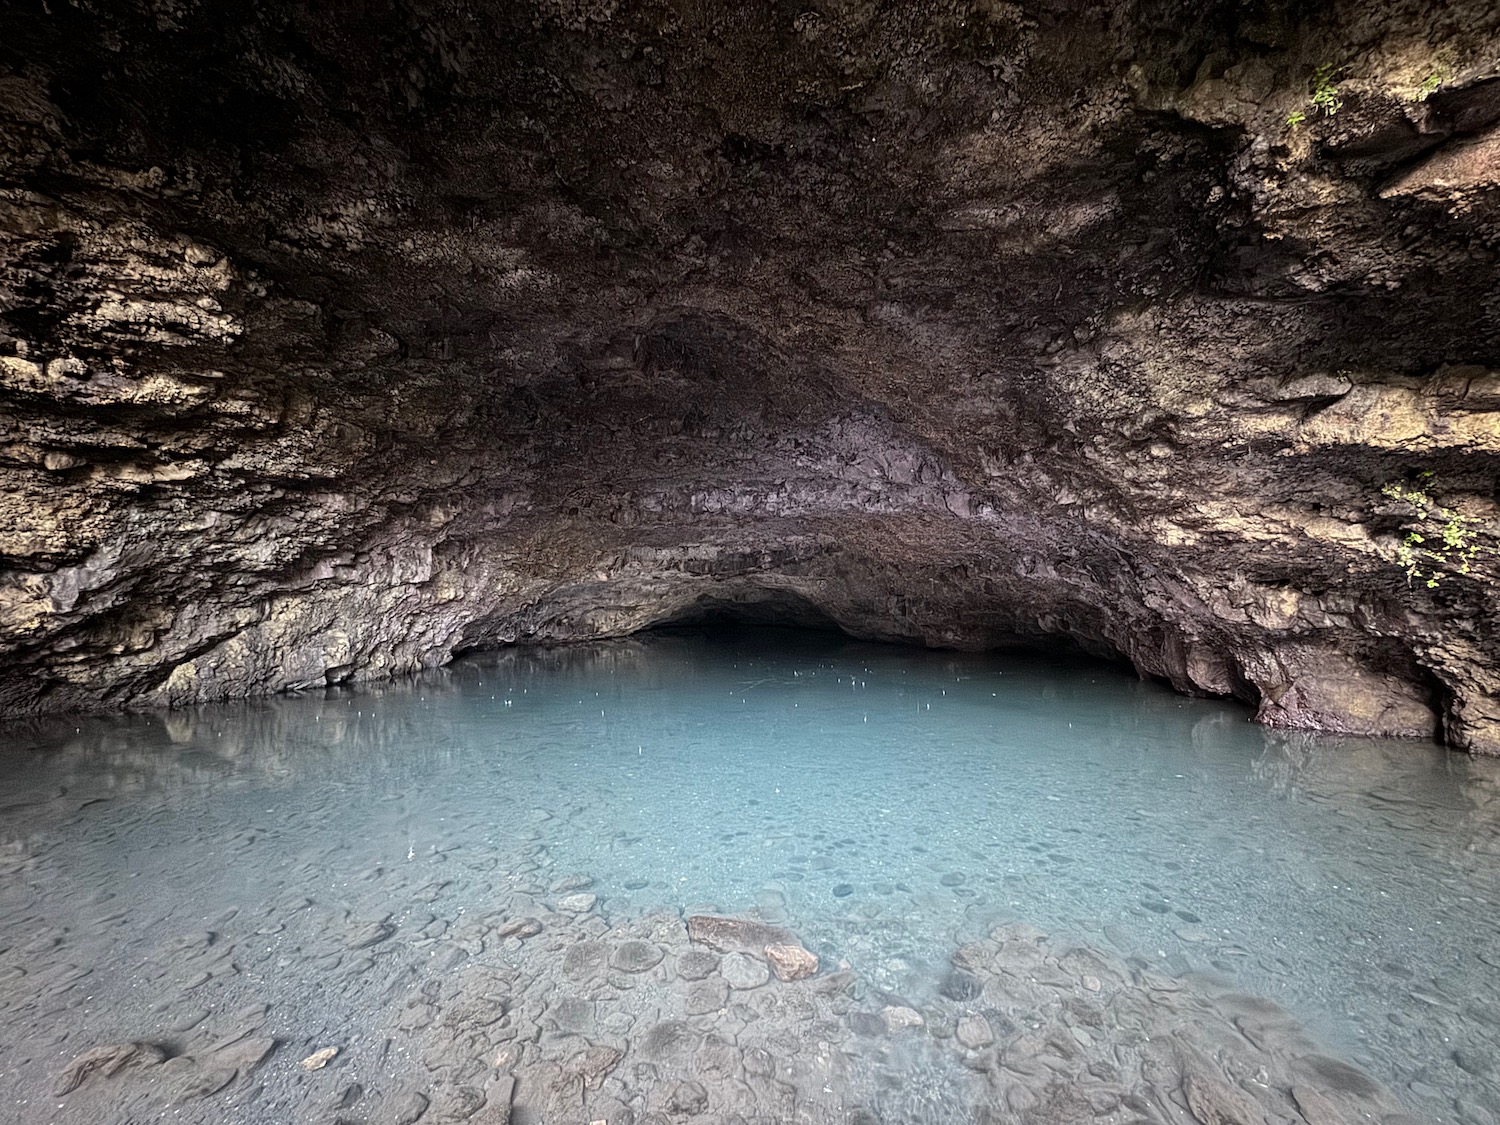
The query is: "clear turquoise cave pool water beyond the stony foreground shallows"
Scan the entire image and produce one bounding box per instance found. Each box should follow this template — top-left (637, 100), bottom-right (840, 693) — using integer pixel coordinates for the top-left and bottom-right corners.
top-left (0, 630), bottom-right (1500, 1122)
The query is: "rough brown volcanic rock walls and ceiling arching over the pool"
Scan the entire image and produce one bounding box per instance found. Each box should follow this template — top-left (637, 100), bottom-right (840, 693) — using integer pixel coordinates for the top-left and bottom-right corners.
top-left (0, 0), bottom-right (1500, 753)
